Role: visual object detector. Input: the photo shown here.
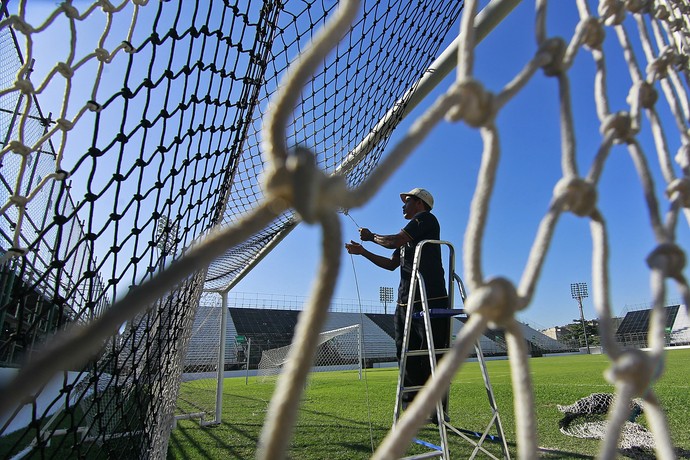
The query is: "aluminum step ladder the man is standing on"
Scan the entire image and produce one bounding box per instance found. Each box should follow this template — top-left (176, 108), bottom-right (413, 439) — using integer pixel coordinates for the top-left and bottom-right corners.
top-left (393, 240), bottom-right (510, 460)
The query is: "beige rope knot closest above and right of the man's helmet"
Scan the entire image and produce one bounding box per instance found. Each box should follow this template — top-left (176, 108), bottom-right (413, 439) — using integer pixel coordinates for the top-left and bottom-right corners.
top-left (446, 79), bottom-right (496, 128)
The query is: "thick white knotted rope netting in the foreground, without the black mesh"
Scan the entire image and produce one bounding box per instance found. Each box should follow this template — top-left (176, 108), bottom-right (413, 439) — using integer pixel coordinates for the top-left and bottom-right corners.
top-left (0, 0), bottom-right (690, 459)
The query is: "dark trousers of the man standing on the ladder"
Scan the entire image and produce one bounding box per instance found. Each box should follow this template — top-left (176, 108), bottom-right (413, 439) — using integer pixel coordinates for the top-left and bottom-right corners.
top-left (395, 305), bottom-right (450, 401)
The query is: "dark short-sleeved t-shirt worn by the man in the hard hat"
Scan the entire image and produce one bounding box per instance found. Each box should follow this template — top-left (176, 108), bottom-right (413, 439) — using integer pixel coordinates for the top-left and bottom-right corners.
top-left (395, 211), bottom-right (447, 309)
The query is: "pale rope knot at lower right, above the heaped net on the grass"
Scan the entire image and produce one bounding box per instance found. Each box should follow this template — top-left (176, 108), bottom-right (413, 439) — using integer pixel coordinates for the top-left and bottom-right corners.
top-left (604, 348), bottom-right (661, 397)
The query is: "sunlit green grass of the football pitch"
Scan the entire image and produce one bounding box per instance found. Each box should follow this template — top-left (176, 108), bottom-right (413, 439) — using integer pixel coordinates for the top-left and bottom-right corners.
top-left (168, 349), bottom-right (690, 459)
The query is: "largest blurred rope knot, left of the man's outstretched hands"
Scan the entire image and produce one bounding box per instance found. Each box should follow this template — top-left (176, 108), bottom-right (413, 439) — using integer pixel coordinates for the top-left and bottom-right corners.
top-left (264, 146), bottom-right (347, 224)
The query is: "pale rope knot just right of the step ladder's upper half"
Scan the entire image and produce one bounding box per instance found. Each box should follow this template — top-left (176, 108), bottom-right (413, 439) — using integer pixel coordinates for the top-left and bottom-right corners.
top-left (465, 277), bottom-right (519, 327)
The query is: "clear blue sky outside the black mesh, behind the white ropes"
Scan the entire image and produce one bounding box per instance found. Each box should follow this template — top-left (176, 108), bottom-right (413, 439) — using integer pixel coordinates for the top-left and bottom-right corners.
top-left (235, 1), bottom-right (690, 327)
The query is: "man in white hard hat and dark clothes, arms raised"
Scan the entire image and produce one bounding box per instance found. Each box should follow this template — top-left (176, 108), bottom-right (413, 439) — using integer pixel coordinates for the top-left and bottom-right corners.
top-left (345, 188), bottom-right (450, 423)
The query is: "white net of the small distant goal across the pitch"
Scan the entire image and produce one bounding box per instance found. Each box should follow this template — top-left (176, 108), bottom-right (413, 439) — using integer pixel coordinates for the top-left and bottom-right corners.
top-left (257, 324), bottom-right (362, 382)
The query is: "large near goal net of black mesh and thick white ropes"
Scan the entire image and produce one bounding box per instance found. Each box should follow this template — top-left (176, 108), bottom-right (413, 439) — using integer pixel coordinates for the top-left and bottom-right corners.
top-left (0, 0), bottom-right (690, 458)
